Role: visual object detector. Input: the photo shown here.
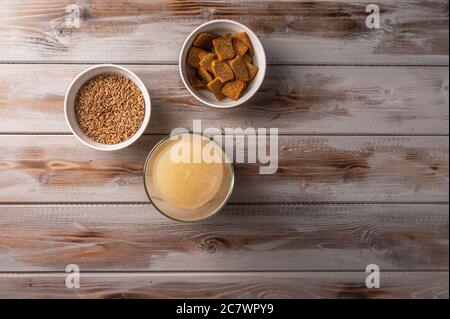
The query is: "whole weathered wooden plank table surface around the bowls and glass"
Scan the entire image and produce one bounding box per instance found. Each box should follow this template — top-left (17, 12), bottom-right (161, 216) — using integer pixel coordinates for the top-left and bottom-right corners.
top-left (0, 0), bottom-right (449, 298)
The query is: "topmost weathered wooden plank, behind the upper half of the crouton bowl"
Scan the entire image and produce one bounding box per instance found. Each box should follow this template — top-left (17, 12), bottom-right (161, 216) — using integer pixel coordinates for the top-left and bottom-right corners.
top-left (0, 0), bottom-right (449, 65)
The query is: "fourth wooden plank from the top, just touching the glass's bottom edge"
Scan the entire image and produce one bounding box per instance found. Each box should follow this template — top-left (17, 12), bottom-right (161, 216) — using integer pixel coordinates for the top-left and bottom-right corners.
top-left (0, 204), bottom-right (449, 272)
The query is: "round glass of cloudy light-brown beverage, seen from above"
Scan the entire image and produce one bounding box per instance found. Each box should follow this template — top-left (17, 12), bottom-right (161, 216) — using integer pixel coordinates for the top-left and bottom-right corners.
top-left (145, 134), bottom-right (233, 221)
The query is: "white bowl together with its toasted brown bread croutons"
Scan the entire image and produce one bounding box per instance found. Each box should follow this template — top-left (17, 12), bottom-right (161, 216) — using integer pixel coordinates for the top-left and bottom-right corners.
top-left (179, 20), bottom-right (266, 108)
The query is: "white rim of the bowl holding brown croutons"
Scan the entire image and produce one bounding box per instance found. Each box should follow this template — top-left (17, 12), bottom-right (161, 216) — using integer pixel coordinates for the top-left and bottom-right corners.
top-left (178, 19), bottom-right (267, 109)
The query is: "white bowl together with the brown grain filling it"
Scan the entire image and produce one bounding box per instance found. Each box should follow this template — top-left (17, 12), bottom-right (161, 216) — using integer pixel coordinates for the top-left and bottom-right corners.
top-left (64, 64), bottom-right (151, 151)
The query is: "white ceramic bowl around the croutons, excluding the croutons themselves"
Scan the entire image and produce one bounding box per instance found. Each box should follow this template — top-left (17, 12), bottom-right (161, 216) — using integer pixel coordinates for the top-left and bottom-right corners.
top-left (179, 20), bottom-right (266, 108)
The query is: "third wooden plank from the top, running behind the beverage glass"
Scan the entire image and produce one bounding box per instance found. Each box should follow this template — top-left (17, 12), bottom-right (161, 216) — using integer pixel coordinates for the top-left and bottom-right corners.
top-left (0, 135), bottom-right (449, 203)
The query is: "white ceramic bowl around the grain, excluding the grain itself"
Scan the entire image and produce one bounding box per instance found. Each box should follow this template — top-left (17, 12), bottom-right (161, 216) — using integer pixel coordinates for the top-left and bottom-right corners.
top-left (64, 64), bottom-right (151, 151)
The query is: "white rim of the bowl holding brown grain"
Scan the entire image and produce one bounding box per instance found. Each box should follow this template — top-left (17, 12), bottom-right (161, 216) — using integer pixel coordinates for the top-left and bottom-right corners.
top-left (64, 64), bottom-right (152, 152)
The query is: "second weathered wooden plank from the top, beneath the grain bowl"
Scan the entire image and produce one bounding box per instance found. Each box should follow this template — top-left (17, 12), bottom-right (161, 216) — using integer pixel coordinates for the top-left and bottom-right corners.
top-left (0, 65), bottom-right (449, 135)
